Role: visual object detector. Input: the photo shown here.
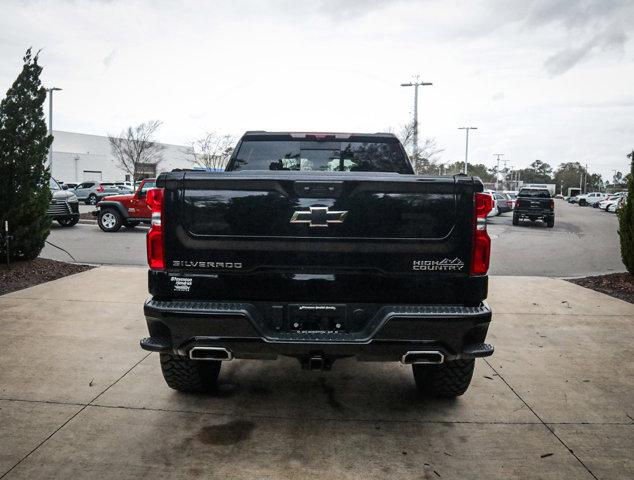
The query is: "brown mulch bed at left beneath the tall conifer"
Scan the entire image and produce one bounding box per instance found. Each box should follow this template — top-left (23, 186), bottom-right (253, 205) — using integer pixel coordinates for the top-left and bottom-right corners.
top-left (0, 258), bottom-right (94, 295)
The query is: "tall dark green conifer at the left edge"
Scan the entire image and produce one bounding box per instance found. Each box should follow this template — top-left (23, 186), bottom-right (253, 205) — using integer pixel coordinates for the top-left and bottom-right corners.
top-left (0, 48), bottom-right (53, 260)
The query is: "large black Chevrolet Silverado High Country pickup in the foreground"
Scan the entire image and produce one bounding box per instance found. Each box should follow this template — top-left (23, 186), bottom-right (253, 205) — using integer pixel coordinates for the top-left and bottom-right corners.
top-left (141, 132), bottom-right (493, 397)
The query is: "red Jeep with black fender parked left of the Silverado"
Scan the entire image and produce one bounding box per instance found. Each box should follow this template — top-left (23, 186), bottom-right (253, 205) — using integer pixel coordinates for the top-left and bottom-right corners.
top-left (93, 178), bottom-right (156, 232)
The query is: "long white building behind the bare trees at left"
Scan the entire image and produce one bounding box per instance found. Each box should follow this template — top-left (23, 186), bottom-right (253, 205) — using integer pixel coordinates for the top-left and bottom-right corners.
top-left (51, 130), bottom-right (192, 183)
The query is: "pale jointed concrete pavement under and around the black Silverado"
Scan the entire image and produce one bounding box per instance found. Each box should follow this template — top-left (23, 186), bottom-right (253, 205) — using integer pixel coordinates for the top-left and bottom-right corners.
top-left (0, 267), bottom-right (634, 480)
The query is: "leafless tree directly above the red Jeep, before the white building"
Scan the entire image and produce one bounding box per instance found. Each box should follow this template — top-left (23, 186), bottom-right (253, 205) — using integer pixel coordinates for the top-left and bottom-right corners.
top-left (108, 120), bottom-right (165, 182)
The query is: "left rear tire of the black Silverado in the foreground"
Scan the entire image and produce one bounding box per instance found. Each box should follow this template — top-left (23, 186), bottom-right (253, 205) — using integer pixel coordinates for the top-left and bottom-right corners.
top-left (160, 353), bottom-right (222, 393)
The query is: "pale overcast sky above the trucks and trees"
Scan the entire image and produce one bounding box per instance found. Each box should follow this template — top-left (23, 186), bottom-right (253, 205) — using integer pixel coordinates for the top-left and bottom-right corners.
top-left (0, 0), bottom-right (634, 178)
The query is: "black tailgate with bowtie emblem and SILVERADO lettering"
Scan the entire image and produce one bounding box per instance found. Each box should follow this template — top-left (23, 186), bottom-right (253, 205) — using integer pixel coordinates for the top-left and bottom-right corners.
top-left (157, 171), bottom-right (482, 276)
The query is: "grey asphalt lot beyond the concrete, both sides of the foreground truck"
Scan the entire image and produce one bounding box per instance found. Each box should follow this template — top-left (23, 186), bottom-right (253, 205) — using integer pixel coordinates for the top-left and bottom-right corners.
top-left (42, 200), bottom-right (625, 277)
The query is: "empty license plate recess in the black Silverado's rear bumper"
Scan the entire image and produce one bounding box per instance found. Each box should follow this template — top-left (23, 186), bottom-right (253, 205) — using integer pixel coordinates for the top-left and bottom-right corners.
top-left (288, 303), bottom-right (348, 332)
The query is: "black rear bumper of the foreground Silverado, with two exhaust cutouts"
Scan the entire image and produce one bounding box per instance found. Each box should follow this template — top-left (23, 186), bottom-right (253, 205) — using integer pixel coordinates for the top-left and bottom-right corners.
top-left (141, 299), bottom-right (493, 361)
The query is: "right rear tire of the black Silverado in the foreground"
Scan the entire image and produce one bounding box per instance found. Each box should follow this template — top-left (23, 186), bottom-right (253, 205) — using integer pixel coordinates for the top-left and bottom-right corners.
top-left (412, 359), bottom-right (475, 398)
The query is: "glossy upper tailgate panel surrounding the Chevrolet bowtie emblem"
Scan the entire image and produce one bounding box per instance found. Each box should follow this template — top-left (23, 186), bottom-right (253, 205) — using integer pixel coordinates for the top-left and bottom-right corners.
top-left (184, 190), bottom-right (455, 238)
